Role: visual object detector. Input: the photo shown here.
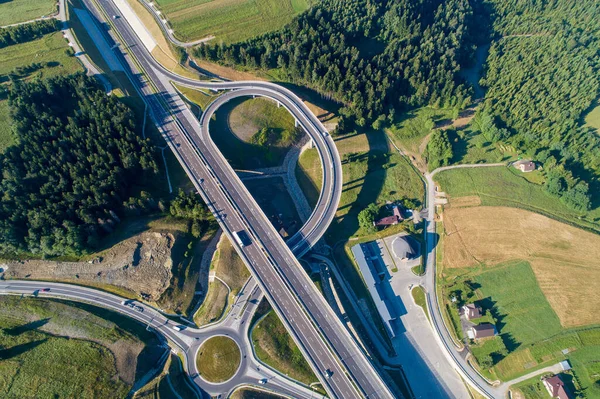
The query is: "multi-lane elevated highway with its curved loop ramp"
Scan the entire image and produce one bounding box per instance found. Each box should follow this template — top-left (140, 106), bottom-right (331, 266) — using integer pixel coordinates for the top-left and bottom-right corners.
top-left (79, 0), bottom-right (394, 398)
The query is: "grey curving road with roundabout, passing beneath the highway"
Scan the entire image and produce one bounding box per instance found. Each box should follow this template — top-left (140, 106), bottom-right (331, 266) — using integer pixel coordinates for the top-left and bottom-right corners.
top-left (0, 279), bottom-right (323, 399)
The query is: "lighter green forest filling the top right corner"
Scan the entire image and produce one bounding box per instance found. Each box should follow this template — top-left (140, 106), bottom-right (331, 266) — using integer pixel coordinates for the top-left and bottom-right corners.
top-left (481, 0), bottom-right (600, 210)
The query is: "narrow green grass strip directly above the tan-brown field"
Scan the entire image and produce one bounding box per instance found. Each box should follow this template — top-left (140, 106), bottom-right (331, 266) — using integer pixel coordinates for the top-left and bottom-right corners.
top-left (435, 166), bottom-right (600, 232)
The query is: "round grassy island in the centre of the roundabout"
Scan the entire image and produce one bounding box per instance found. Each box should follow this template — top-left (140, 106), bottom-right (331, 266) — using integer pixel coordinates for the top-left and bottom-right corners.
top-left (196, 336), bottom-right (241, 382)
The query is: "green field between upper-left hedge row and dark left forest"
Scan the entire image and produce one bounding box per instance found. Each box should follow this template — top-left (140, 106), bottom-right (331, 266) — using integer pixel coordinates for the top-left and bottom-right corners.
top-left (0, 32), bottom-right (83, 79)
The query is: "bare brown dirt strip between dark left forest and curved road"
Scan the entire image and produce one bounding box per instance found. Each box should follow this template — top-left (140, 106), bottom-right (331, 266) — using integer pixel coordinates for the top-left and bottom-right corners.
top-left (0, 232), bottom-right (176, 301)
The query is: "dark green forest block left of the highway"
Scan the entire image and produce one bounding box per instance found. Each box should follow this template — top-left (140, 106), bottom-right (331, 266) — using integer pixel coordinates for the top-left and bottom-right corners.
top-left (0, 74), bottom-right (158, 256)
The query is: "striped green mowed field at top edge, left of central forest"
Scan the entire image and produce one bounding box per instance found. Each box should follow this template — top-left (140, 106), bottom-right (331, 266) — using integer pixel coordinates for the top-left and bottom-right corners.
top-left (156, 0), bottom-right (309, 42)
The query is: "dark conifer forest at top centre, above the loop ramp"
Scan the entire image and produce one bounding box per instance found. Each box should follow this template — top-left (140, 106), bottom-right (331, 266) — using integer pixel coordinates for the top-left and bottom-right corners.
top-left (194, 0), bottom-right (480, 130)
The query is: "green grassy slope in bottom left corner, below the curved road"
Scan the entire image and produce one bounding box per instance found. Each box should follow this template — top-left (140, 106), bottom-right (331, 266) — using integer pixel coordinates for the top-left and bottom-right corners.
top-left (0, 296), bottom-right (158, 398)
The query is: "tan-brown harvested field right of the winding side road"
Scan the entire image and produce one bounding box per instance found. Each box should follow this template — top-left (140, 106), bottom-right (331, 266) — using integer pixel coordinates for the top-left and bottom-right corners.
top-left (443, 207), bottom-right (600, 327)
